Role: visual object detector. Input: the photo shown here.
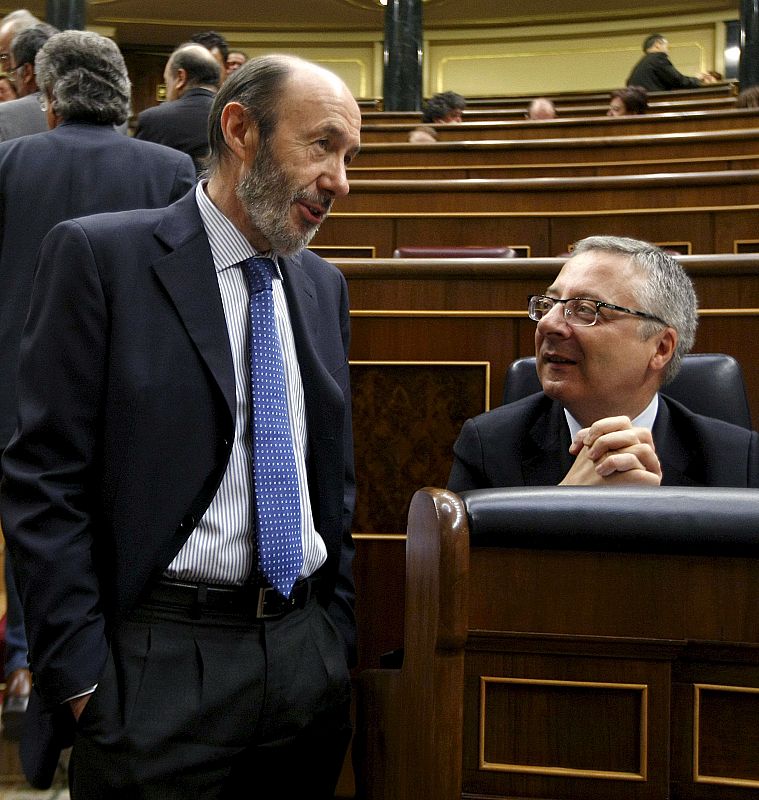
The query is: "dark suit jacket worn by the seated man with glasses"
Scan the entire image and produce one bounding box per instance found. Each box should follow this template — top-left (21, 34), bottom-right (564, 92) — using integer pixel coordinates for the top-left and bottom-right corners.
top-left (448, 392), bottom-right (759, 491)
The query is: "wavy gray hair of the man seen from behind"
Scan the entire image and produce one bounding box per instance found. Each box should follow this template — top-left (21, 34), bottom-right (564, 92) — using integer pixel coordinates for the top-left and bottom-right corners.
top-left (35, 31), bottom-right (131, 125)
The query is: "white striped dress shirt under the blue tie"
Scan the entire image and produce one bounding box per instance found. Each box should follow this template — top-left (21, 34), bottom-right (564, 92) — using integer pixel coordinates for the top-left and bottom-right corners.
top-left (166, 181), bottom-right (327, 584)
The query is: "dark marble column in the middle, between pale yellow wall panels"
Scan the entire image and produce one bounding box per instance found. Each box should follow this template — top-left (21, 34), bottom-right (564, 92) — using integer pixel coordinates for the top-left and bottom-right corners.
top-left (383, 0), bottom-right (423, 111)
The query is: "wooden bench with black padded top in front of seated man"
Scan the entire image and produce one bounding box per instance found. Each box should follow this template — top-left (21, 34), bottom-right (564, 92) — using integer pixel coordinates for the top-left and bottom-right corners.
top-left (354, 487), bottom-right (759, 800)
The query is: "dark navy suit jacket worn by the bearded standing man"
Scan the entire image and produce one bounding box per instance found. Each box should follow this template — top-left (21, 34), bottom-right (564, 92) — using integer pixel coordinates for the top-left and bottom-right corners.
top-left (1, 192), bottom-right (354, 783)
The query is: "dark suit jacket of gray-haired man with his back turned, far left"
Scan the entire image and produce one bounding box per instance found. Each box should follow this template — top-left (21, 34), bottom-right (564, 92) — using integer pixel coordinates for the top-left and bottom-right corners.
top-left (0, 122), bottom-right (195, 450)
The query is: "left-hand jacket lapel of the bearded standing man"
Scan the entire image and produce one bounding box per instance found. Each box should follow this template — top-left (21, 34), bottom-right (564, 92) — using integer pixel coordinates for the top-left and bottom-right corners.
top-left (153, 190), bottom-right (235, 419)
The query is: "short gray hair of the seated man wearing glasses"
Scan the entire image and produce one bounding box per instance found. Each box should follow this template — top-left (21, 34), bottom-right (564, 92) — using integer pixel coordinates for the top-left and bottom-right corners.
top-left (570, 236), bottom-right (698, 383)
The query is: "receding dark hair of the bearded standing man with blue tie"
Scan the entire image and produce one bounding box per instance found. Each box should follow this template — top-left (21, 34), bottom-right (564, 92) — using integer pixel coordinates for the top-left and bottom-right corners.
top-left (208, 55), bottom-right (296, 173)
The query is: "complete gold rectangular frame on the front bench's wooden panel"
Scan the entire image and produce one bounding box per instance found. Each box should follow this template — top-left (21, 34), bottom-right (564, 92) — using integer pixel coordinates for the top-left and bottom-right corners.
top-left (479, 675), bottom-right (648, 781)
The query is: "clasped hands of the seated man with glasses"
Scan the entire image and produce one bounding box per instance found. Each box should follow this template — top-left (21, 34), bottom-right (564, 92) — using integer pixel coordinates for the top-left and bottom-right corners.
top-left (559, 417), bottom-right (662, 486)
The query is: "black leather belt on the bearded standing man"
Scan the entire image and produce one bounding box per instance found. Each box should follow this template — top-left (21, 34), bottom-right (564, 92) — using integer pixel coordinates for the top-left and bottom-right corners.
top-left (144, 577), bottom-right (319, 619)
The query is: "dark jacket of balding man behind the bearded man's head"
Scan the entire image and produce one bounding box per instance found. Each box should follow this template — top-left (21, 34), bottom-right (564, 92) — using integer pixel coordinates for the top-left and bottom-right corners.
top-left (134, 88), bottom-right (215, 172)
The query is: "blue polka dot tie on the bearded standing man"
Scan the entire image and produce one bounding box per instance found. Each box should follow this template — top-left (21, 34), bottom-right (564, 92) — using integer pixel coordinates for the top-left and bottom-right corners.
top-left (242, 257), bottom-right (303, 597)
